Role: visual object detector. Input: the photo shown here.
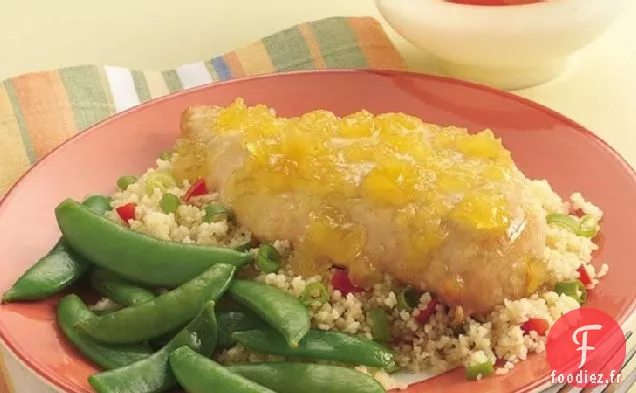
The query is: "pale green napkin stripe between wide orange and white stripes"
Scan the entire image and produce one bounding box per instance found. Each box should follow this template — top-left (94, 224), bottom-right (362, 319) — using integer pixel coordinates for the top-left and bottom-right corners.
top-left (59, 65), bottom-right (115, 131)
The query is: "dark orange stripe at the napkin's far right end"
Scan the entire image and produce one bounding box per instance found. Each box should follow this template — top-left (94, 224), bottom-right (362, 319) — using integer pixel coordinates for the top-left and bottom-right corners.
top-left (347, 17), bottom-right (406, 70)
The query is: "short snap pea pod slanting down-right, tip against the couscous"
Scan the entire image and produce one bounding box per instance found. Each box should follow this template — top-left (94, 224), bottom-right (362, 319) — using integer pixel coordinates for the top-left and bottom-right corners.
top-left (229, 280), bottom-right (311, 348)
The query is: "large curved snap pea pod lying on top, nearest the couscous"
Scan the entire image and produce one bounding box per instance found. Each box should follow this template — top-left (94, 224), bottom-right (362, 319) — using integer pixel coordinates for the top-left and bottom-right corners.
top-left (55, 199), bottom-right (252, 287)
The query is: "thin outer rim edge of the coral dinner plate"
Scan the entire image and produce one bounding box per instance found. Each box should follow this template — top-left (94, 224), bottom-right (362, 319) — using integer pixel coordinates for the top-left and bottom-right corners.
top-left (0, 68), bottom-right (636, 393)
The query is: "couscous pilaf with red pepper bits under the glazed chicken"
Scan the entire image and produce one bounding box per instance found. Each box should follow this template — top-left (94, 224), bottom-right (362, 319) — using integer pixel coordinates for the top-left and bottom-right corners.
top-left (106, 151), bottom-right (608, 389)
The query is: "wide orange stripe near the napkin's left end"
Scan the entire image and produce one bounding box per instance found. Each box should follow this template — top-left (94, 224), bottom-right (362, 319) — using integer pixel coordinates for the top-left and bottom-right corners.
top-left (13, 71), bottom-right (77, 158)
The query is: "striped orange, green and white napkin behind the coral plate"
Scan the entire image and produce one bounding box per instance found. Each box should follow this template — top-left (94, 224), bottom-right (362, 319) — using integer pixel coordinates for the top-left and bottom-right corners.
top-left (0, 17), bottom-right (405, 393)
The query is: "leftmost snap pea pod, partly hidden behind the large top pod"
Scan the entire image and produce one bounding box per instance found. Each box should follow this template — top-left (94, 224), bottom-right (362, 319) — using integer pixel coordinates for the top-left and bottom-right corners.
top-left (2, 195), bottom-right (110, 302)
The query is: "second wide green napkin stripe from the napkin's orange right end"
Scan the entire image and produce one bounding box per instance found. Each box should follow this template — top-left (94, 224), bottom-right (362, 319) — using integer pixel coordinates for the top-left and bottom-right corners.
top-left (263, 27), bottom-right (314, 71)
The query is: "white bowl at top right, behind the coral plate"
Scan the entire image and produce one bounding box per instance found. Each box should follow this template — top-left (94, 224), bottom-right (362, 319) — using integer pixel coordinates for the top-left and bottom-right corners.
top-left (376, 0), bottom-right (626, 90)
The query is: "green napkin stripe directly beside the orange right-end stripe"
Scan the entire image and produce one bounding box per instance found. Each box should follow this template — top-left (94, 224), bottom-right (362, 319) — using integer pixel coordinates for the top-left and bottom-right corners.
top-left (309, 18), bottom-right (369, 68)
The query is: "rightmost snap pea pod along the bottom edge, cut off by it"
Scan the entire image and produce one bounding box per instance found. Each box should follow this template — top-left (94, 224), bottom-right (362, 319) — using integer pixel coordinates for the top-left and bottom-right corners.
top-left (228, 362), bottom-right (385, 393)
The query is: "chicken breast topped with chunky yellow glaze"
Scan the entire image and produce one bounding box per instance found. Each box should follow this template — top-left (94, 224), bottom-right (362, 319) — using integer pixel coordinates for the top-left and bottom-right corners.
top-left (174, 99), bottom-right (546, 314)
